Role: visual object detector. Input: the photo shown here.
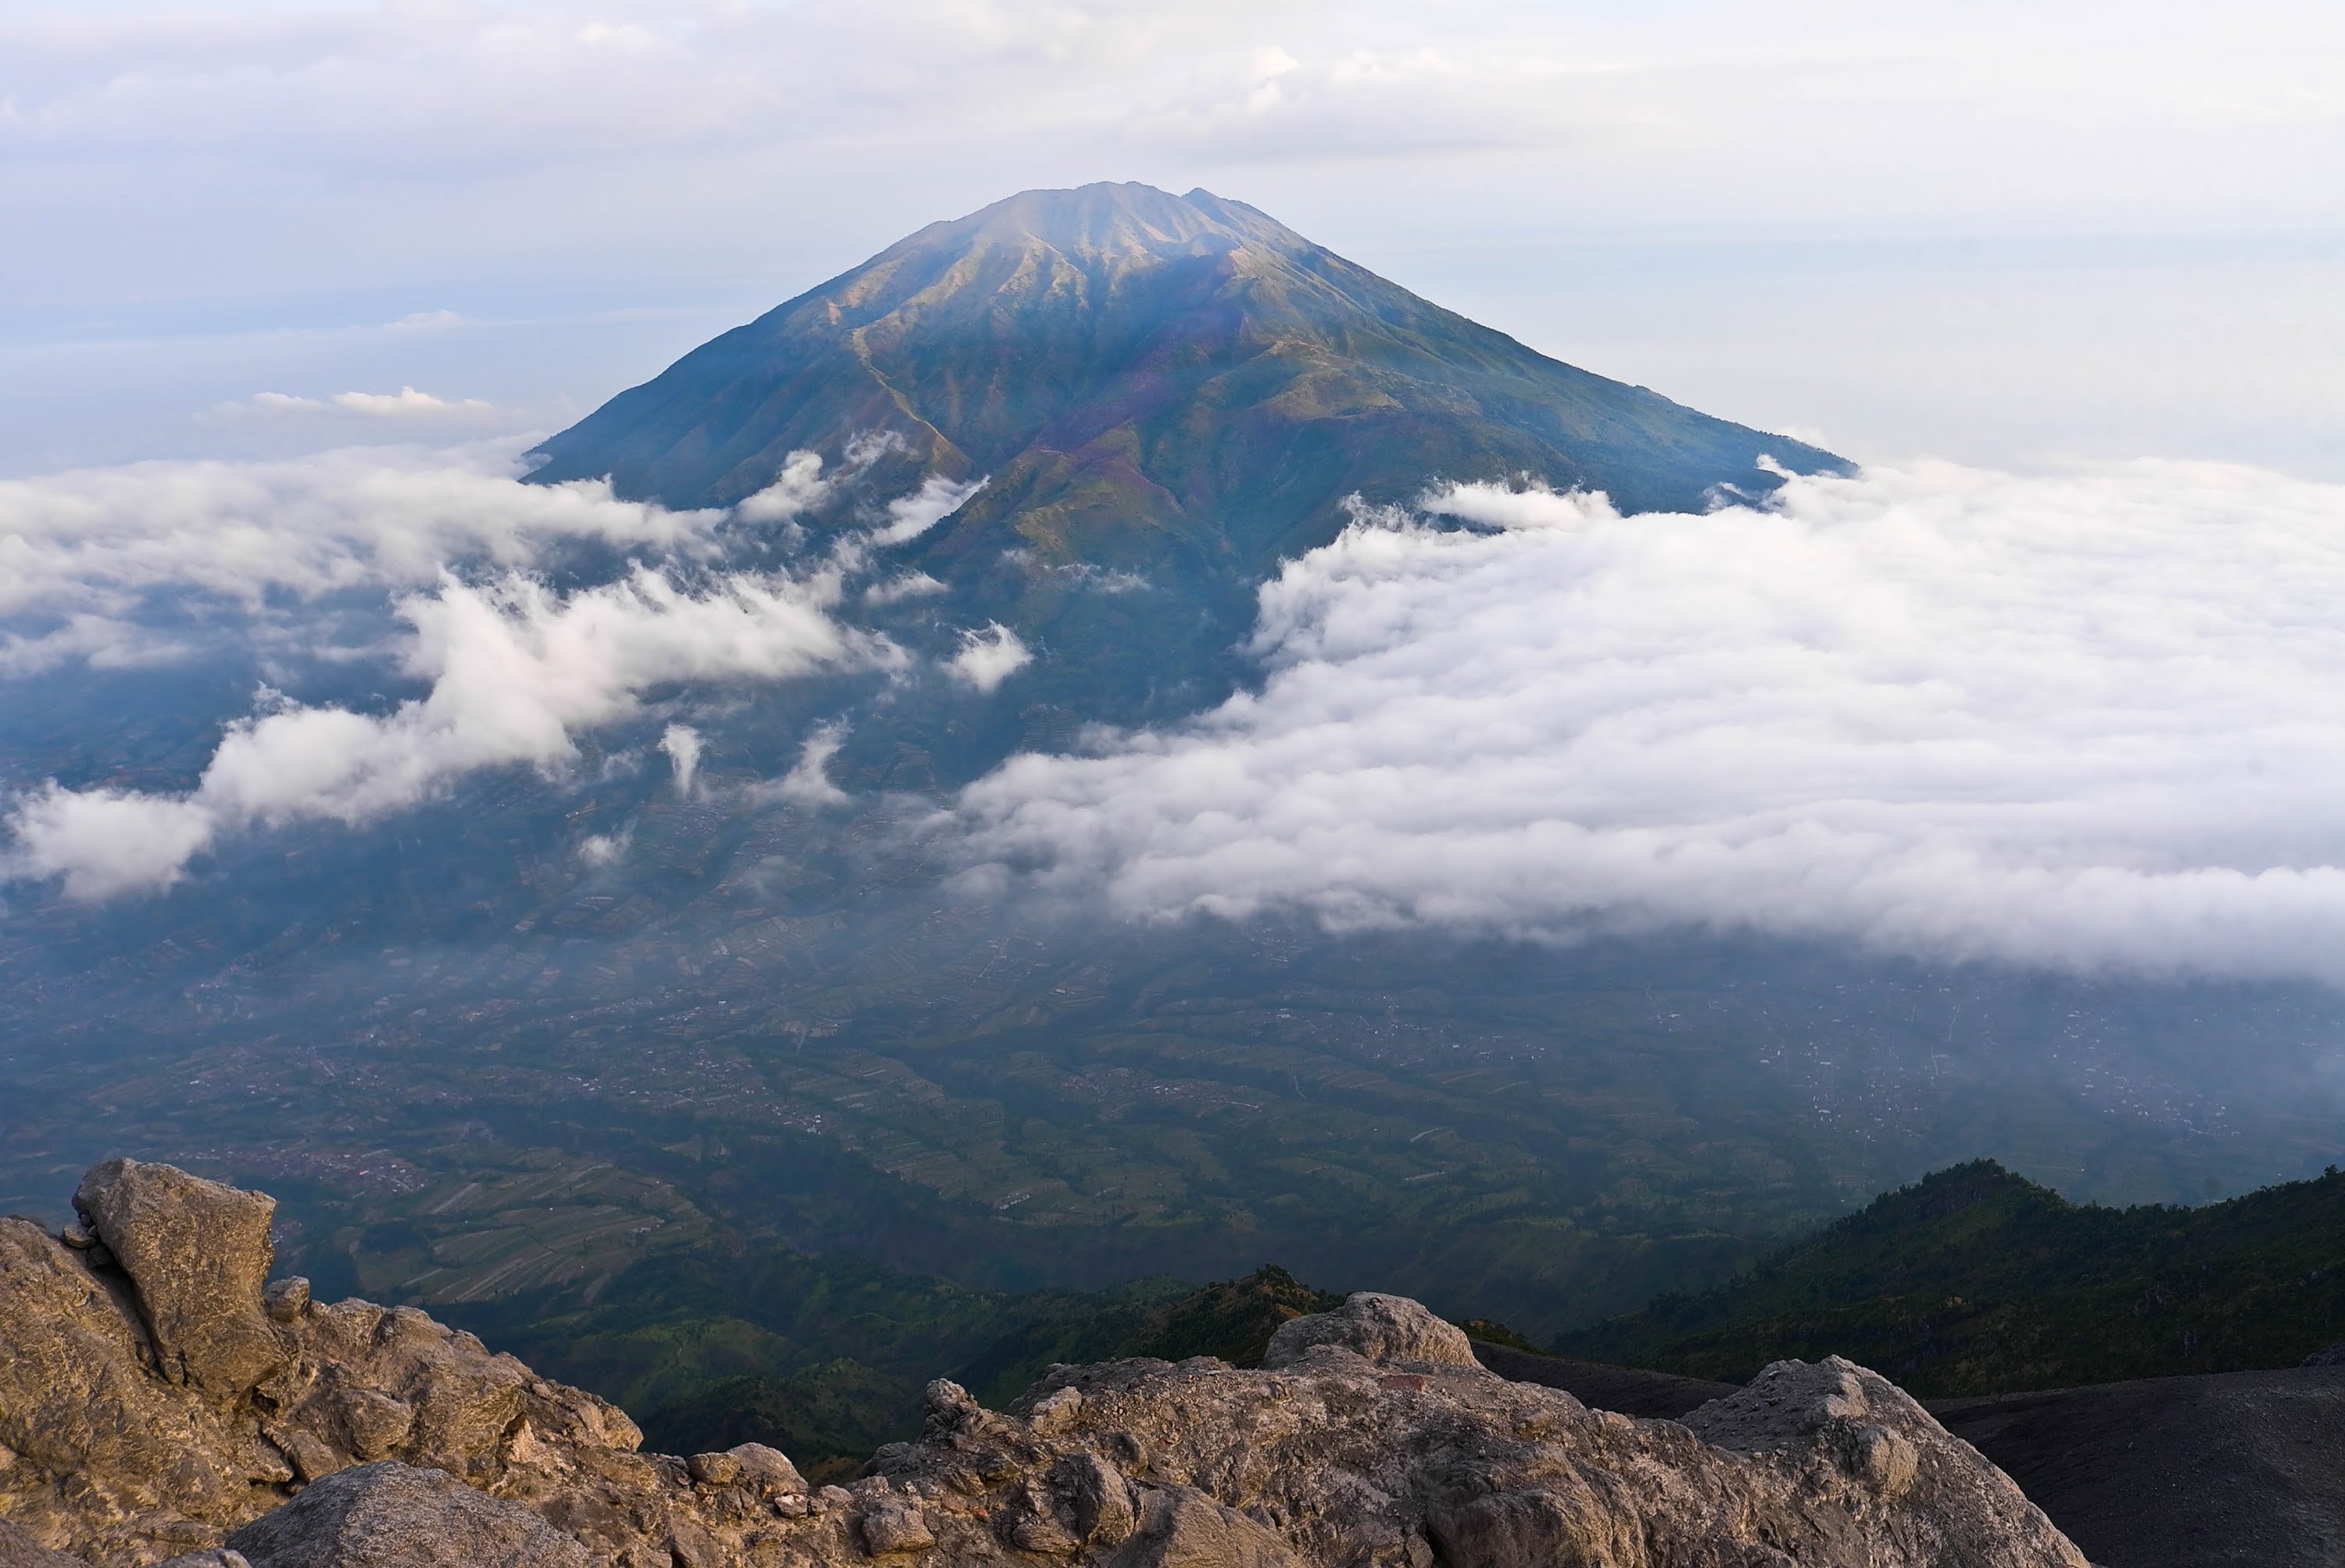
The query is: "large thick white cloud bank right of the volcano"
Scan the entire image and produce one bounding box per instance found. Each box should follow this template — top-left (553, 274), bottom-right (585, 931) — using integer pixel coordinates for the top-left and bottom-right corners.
top-left (957, 462), bottom-right (2345, 979)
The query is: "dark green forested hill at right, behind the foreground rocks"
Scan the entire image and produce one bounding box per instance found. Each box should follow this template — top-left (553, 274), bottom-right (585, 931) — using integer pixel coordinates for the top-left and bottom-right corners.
top-left (1557, 1160), bottom-right (2345, 1397)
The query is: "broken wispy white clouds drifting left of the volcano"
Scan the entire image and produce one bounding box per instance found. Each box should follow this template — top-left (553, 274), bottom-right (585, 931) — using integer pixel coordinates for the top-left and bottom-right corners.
top-left (0, 443), bottom-right (1029, 902)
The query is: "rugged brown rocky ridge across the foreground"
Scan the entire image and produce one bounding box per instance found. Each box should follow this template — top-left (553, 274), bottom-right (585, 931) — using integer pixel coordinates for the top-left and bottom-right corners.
top-left (0, 1160), bottom-right (2085, 1568)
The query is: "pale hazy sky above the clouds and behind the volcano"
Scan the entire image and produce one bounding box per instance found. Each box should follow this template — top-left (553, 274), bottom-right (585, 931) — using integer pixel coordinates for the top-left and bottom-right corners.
top-left (13, 0), bottom-right (2345, 478)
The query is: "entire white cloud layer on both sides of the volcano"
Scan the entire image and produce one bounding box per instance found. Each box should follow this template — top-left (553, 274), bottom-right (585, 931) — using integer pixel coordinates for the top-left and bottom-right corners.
top-left (0, 443), bottom-right (2345, 979)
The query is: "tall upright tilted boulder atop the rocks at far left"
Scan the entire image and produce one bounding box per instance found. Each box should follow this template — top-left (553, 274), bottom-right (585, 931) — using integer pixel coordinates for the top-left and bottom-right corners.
top-left (73, 1160), bottom-right (288, 1397)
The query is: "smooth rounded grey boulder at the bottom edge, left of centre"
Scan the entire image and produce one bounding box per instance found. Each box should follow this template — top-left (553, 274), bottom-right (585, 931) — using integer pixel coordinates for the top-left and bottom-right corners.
top-left (227, 1460), bottom-right (591, 1568)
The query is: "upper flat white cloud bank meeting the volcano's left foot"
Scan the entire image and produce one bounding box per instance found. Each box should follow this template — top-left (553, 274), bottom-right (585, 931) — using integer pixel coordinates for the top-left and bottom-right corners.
top-left (0, 441), bottom-right (725, 617)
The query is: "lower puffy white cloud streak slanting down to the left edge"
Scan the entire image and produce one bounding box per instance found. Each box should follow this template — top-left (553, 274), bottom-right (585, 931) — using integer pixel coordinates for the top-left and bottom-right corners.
top-left (7, 570), bottom-right (903, 900)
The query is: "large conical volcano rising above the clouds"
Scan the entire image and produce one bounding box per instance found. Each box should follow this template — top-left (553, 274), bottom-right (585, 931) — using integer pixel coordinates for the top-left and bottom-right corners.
top-left (532, 185), bottom-right (1838, 745)
